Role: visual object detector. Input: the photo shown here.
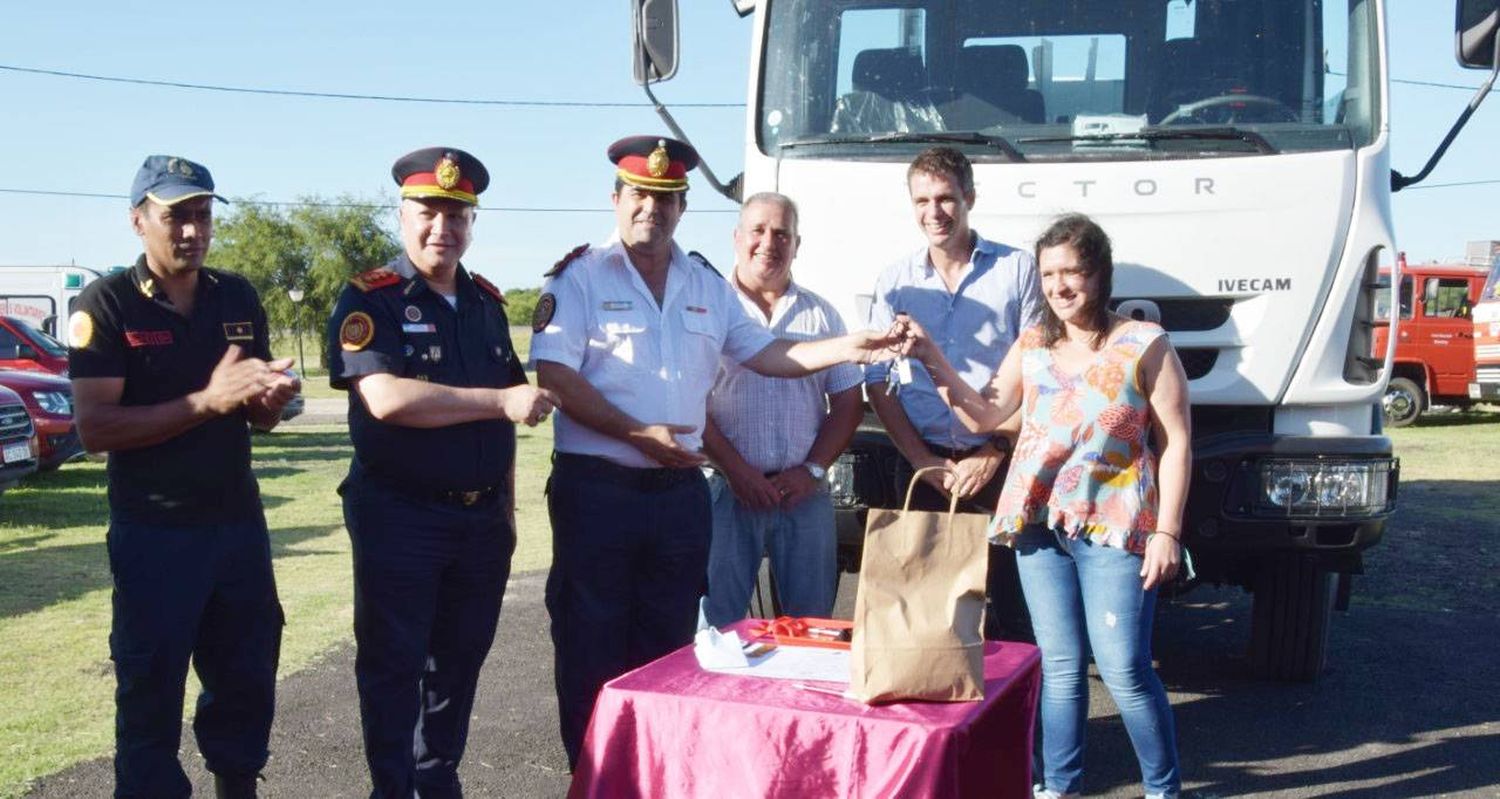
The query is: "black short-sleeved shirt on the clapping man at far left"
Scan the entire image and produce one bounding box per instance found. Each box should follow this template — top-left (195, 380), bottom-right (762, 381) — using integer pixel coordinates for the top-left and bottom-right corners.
top-left (68, 255), bottom-right (270, 525)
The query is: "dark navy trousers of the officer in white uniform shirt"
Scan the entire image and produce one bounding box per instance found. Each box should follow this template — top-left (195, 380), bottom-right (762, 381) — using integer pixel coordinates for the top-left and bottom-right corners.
top-left (548, 453), bottom-right (713, 766)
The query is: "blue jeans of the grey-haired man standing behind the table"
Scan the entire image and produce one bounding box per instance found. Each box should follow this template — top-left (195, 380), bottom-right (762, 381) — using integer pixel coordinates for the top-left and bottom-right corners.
top-left (704, 474), bottom-right (839, 627)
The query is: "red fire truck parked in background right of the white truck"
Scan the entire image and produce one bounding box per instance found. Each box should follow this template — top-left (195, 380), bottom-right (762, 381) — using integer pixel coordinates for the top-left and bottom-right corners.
top-left (1371, 253), bottom-right (1485, 427)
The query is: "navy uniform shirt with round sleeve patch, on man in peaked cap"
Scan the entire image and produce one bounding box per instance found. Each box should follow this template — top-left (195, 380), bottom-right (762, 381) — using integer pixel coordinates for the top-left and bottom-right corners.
top-left (327, 255), bottom-right (527, 493)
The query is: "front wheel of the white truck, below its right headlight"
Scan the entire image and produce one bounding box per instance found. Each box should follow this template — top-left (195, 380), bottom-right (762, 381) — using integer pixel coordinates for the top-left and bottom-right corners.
top-left (1250, 555), bottom-right (1338, 682)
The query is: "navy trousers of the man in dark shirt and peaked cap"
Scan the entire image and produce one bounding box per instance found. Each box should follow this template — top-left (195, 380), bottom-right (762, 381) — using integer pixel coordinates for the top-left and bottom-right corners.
top-left (339, 477), bottom-right (516, 799)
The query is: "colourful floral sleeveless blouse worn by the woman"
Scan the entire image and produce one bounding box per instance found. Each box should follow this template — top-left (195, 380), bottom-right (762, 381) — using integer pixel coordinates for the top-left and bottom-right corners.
top-left (990, 322), bottom-right (1166, 553)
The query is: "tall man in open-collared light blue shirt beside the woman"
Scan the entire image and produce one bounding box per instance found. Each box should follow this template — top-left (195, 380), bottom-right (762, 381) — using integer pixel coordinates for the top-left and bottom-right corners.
top-left (864, 147), bottom-right (1041, 640)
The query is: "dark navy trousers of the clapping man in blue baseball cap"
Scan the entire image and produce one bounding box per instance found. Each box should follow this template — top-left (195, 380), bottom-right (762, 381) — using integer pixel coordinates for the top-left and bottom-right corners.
top-left (107, 513), bottom-right (284, 799)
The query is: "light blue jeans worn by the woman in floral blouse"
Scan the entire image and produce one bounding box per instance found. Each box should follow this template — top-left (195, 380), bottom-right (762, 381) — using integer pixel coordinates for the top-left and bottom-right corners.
top-left (1016, 526), bottom-right (1181, 795)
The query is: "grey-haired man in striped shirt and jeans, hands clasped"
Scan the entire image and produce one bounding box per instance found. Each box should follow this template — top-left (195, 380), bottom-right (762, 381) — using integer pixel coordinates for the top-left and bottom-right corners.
top-left (704, 192), bottom-right (861, 627)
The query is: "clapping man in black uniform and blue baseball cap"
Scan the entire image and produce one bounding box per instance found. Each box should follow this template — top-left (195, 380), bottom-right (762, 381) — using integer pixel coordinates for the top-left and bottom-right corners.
top-left (68, 156), bottom-right (299, 798)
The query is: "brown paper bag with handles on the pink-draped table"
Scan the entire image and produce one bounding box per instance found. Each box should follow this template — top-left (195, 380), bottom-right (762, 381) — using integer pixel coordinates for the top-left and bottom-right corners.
top-left (849, 466), bottom-right (990, 705)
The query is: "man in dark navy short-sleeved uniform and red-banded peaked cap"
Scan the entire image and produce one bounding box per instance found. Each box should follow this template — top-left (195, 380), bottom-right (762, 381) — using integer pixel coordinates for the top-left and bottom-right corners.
top-left (329, 147), bottom-right (554, 798)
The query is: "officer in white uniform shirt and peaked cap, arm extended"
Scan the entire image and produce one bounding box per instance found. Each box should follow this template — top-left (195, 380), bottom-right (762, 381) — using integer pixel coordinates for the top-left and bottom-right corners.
top-left (531, 136), bottom-right (893, 765)
